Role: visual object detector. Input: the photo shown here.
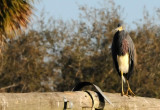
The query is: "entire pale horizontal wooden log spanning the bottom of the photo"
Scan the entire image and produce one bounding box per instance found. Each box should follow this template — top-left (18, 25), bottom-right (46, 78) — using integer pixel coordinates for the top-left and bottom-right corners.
top-left (0, 91), bottom-right (160, 110)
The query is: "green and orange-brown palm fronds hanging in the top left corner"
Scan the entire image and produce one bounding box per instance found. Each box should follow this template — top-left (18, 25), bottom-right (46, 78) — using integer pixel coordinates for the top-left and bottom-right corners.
top-left (0, 0), bottom-right (33, 45)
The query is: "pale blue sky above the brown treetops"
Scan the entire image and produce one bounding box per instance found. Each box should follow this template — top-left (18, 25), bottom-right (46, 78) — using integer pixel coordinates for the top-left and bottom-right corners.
top-left (34, 0), bottom-right (160, 28)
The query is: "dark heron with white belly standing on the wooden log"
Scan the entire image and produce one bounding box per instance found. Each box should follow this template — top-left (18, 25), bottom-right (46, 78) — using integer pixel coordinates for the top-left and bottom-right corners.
top-left (111, 24), bottom-right (136, 96)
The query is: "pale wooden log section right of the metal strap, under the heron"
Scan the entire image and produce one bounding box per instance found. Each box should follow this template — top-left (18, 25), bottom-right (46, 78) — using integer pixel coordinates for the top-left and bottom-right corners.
top-left (105, 93), bottom-right (160, 110)
